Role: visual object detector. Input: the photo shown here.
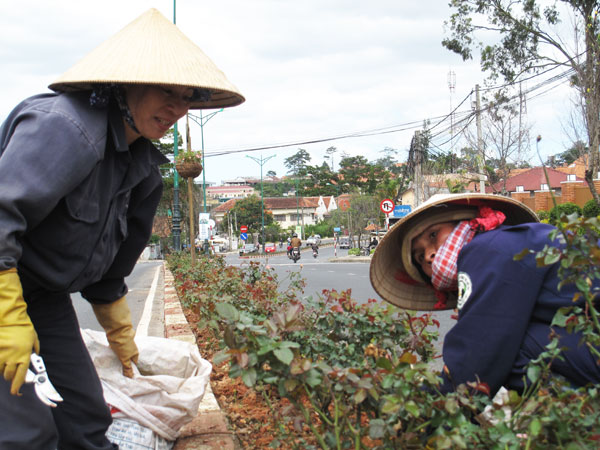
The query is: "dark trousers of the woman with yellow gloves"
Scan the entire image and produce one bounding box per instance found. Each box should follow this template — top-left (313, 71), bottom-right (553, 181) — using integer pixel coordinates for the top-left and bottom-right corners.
top-left (0, 283), bottom-right (118, 450)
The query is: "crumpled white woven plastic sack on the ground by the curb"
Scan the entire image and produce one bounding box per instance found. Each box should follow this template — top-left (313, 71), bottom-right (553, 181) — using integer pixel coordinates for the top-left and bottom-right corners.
top-left (81, 329), bottom-right (212, 441)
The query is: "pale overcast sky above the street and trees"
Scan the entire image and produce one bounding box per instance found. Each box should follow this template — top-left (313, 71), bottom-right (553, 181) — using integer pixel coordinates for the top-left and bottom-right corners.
top-left (0, 0), bottom-right (570, 184)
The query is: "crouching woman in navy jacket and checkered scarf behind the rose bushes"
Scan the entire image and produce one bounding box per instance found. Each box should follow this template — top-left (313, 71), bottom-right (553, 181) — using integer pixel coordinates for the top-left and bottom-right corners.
top-left (370, 194), bottom-right (600, 396)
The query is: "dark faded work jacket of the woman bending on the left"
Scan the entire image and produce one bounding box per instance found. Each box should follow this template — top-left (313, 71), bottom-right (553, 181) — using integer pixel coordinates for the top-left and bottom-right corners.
top-left (0, 92), bottom-right (168, 303)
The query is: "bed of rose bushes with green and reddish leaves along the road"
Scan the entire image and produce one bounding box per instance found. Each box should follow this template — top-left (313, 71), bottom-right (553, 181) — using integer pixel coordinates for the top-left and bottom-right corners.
top-left (168, 210), bottom-right (600, 449)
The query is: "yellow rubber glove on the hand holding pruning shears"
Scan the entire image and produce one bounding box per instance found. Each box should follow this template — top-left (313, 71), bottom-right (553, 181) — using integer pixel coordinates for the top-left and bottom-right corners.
top-left (0, 268), bottom-right (40, 395)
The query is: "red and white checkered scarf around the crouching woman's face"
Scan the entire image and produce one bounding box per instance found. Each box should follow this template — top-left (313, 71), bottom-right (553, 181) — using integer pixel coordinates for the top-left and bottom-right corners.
top-left (431, 206), bottom-right (506, 300)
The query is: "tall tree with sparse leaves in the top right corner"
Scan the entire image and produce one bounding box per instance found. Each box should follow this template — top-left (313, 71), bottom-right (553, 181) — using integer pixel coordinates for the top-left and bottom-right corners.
top-left (442, 0), bottom-right (600, 205)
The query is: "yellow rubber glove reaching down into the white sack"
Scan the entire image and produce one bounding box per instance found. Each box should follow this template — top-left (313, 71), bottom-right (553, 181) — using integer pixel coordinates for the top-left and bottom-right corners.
top-left (92, 297), bottom-right (139, 378)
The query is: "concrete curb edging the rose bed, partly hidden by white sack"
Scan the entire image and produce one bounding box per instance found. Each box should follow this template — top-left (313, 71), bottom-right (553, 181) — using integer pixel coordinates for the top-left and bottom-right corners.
top-left (163, 263), bottom-right (241, 450)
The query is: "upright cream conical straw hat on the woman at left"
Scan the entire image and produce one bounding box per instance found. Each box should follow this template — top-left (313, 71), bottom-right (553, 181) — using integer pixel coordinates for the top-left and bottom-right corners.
top-left (48, 9), bottom-right (245, 109)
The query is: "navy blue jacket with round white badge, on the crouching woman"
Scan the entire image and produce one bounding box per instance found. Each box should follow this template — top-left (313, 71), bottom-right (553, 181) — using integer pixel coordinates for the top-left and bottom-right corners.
top-left (442, 223), bottom-right (600, 395)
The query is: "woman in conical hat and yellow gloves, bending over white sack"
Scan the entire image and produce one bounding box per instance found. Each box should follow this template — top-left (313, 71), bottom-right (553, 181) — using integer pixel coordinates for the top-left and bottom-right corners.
top-left (0, 10), bottom-right (244, 450)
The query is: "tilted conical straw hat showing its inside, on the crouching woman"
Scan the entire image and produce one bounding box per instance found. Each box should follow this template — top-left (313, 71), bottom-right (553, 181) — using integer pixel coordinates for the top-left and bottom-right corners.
top-left (369, 194), bottom-right (539, 311)
